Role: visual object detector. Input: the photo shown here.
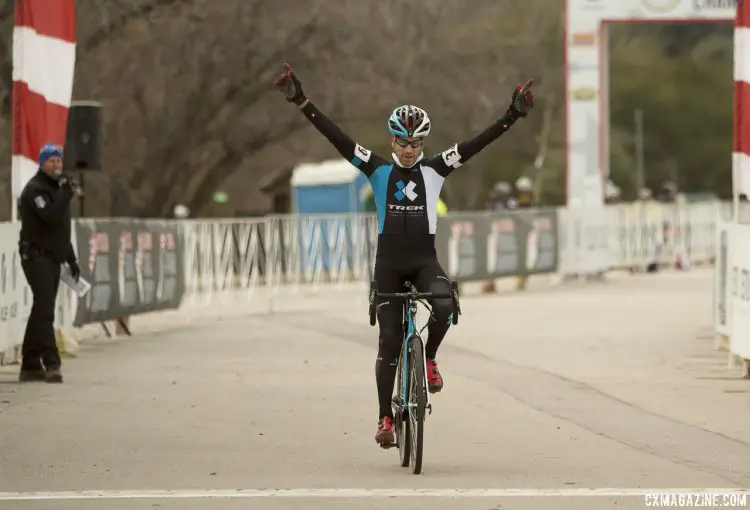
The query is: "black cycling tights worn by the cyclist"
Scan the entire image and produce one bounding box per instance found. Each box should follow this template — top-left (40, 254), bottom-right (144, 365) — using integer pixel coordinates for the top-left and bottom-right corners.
top-left (375, 260), bottom-right (453, 418)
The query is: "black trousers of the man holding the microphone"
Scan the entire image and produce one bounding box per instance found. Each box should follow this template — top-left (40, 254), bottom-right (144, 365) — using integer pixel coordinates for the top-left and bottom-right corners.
top-left (21, 255), bottom-right (61, 370)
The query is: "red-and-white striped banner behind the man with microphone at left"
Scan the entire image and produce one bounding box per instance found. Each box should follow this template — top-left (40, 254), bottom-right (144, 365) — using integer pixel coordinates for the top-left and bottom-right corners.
top-left (11, 0), bottom-right (76, 221)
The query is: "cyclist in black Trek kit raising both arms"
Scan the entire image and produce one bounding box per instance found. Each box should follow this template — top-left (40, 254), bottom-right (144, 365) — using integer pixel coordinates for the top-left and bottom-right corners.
top-left (276, 64), bottom-right (534, 445)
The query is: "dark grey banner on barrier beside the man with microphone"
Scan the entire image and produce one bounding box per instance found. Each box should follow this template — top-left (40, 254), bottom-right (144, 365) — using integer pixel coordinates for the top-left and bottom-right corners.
top-left (74, 219), bottom-right (185, 326)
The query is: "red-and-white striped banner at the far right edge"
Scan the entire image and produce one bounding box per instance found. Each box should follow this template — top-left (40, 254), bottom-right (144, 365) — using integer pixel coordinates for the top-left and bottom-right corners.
top-left (732, 0), bottom-right (750, 217)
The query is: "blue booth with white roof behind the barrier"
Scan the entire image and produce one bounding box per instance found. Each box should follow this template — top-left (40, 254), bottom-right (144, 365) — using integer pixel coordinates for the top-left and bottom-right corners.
top-left (290, 158), bottom-right (370, 214)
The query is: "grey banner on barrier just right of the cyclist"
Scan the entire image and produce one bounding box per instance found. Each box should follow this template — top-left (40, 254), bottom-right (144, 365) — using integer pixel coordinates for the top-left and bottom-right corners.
top-left (436, 210), bottom-right (558, 281)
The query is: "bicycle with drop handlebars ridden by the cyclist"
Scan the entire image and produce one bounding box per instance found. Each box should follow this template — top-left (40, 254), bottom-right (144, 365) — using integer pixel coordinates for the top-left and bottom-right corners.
top-left (369, 280), bottom-right (461, 475)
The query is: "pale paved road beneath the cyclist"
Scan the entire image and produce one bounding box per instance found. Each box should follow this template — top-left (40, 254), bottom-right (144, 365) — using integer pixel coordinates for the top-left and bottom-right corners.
top-left (0, 270), bottom-right (750, 510)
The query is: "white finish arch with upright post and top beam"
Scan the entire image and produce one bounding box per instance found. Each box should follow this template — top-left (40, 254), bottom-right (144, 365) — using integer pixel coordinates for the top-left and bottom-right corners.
top-left (563, 0), bottom-right (736, 209)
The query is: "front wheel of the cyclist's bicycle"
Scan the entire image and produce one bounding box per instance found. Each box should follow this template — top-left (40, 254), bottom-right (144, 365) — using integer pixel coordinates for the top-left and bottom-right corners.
top-left (407, 335), bottom-right (427, 475)
